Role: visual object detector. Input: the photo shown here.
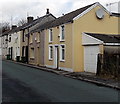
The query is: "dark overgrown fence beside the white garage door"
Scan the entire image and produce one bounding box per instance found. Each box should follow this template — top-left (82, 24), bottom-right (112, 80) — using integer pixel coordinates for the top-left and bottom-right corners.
top-left (97, 53), bottom-right (120, 78)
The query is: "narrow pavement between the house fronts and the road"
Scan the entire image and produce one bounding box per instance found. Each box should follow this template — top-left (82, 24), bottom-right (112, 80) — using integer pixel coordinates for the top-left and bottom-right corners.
top-left (3, 60), bottom-right (120, 90)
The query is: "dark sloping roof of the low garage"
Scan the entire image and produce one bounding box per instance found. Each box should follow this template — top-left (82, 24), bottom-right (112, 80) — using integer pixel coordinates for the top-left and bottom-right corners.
top-left (85, 33), bottom-right (120, 43)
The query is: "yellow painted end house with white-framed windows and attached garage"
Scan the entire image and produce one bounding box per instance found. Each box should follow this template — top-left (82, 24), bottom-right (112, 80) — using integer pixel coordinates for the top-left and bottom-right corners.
top-left (40, 2), bottom-right (120, 73)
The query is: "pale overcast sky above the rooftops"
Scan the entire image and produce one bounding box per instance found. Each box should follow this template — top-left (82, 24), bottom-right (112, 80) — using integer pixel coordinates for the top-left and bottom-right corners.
top-left (0, 0), bottom-right (120, 24)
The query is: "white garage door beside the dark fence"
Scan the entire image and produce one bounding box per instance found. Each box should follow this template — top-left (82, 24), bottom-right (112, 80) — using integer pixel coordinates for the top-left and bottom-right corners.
top-left (84, 46), bottom-right (100, 73)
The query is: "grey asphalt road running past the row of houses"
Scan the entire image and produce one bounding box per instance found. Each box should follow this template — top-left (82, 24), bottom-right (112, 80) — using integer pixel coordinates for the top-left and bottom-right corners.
top-left (2, 61), bottom-right (119, 102)
